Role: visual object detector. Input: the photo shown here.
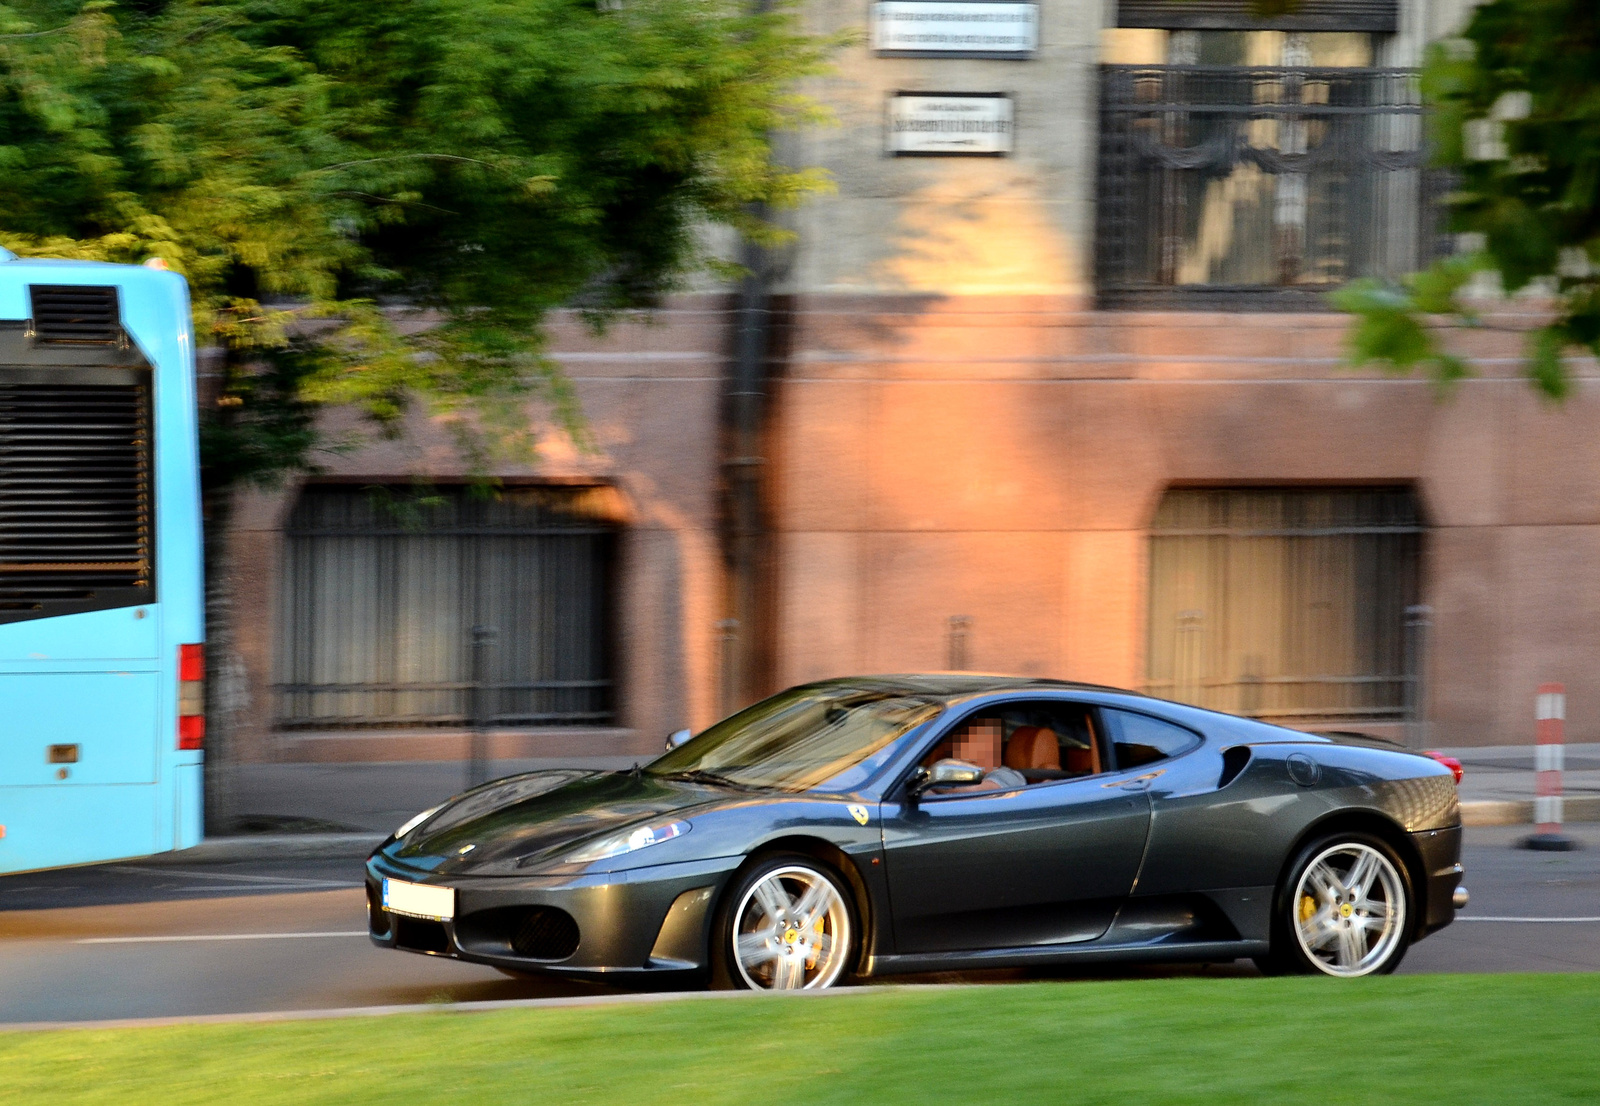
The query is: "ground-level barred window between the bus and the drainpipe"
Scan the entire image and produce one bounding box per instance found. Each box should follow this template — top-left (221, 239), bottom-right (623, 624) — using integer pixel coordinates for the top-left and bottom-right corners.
top-left (275, 485), bottom-right (616, 728)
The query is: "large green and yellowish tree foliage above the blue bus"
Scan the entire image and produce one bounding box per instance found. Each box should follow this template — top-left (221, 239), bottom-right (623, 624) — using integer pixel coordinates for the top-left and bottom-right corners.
top-left (0, 0), bottom-right (829, 487)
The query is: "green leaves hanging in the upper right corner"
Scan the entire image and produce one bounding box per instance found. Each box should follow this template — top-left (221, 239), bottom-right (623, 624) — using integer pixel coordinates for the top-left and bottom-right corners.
top-left (1334, 0), bottom-right (1600, 399)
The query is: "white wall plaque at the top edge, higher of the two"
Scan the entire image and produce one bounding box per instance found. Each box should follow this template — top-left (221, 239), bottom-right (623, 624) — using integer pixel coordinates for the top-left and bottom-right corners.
top-left (872, 0), bottom-right (1038, 58)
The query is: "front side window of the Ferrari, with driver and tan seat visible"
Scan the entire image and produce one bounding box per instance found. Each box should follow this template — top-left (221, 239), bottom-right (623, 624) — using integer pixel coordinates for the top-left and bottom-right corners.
top-left (922, 701), bottom-right (1109, 794)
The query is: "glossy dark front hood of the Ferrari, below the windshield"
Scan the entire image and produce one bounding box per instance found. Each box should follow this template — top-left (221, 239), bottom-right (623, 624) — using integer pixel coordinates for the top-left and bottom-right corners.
top-left (379, 771), bottom-right (728, 872)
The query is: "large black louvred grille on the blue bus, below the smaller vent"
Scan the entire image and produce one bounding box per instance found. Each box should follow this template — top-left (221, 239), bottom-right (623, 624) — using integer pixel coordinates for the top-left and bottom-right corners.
top-left (0, 383), bottom-right (152, 615)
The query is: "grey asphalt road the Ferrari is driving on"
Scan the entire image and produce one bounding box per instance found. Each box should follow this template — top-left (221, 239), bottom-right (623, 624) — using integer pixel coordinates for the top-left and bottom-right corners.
top-left (0, 824), bottom-right (1600, 1023)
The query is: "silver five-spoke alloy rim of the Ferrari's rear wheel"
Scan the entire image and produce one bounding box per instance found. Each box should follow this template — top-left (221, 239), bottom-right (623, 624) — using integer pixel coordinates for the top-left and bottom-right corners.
top-left (1291, 842), bottom-right (1406, 976)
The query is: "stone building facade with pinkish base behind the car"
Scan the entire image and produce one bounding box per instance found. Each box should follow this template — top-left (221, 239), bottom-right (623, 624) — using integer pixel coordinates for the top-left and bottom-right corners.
top-left (234, 0), bottom-right (1600, 760)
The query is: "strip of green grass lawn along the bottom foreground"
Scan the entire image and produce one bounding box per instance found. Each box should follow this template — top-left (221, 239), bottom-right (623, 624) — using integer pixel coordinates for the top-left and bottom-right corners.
top-left (0, 975), bottom-right (1600, 1106)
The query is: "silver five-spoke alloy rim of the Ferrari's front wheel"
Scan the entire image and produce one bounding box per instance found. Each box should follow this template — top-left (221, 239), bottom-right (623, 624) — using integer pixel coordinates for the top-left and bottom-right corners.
top-left (733, 864), bottom-right (850, 991)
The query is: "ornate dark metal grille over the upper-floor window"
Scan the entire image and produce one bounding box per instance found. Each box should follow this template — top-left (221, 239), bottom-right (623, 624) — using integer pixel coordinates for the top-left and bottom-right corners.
top-left (1096, 66), bottom-right (1446, 311)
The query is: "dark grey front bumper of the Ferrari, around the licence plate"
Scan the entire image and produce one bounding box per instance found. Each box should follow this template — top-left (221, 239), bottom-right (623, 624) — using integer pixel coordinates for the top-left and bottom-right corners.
top-left (366, 855), bottom-right (739, 976)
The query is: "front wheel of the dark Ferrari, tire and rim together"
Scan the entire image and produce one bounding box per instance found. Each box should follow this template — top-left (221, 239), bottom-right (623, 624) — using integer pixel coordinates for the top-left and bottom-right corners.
top-left (714, 855), bottom-right (856, 991)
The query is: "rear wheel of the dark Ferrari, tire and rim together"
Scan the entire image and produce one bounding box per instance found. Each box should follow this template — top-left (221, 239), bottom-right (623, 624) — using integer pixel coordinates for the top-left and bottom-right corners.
top-left (1256, 834), bottom-right (1416, 980)
